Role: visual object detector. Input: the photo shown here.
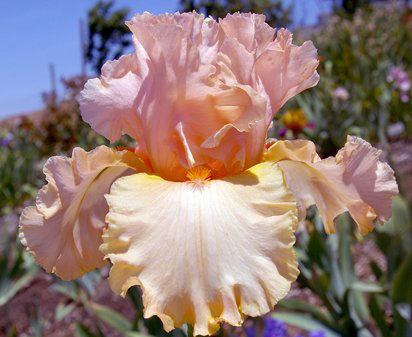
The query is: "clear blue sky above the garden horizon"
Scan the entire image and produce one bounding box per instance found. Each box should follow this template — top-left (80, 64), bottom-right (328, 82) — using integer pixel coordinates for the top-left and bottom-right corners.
top-left (0, 0), bottom-right (328, 118)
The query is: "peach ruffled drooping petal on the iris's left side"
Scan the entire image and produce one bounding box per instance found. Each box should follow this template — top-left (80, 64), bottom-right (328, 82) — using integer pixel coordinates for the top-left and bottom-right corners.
top-left (20, 146), bottom-right (145, 280)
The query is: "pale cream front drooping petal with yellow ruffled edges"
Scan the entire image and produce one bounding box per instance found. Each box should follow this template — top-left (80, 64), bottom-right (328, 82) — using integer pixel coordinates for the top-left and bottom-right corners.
top-left (101, 163), bottom-right (298, 335)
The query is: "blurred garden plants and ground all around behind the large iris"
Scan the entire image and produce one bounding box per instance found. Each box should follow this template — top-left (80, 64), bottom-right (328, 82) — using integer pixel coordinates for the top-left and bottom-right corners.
top-left (0, 0), bottom-right (412, 337)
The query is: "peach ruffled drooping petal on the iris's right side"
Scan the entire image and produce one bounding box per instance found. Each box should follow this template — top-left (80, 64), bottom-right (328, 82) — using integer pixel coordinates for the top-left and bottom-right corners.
top-left (265, 136), bottom-right (398, 234)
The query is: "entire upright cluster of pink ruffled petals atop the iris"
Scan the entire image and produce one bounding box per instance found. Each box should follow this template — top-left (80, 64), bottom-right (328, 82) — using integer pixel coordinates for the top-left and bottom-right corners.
top-left (80, 12), bottom-right (318, 181)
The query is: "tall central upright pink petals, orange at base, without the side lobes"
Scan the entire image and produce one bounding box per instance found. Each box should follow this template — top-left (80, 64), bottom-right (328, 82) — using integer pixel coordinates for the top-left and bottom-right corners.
top-left (127, 13), bottom-right (266, 181)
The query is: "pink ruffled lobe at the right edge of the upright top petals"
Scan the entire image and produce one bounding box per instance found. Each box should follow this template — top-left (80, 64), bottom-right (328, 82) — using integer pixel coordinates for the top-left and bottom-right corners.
top-left (255, 28), bottom-right (319, 123)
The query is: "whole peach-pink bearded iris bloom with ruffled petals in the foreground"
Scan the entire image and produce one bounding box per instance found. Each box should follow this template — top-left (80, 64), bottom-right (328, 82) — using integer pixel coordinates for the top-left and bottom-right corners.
top-left (20, 12), bottom-right (397, 335)
